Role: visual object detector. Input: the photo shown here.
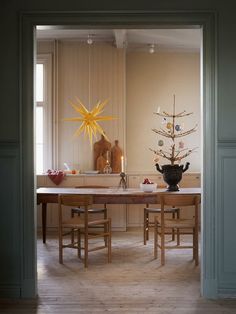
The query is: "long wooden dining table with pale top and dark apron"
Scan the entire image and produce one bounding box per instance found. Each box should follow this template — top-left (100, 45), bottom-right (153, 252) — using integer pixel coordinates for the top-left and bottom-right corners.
top-left (37, 187), bottom-right (201, 243)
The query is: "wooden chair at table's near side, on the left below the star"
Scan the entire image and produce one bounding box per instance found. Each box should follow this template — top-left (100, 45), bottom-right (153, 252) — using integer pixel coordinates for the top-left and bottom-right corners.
top-left (58, 194), bottom-right (111, 268)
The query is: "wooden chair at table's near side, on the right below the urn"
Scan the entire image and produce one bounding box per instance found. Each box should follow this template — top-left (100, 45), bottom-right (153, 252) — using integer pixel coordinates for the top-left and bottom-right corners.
top-left (154, 193), bottom-right (200, 266)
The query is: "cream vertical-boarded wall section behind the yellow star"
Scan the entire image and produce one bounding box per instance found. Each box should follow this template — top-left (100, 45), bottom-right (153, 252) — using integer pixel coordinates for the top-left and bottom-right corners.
top-left (38, 40), bottom-right (125, 172)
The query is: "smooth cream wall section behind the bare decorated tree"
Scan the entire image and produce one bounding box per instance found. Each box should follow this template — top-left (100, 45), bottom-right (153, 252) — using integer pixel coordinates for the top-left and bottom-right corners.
top-left (126, 52), bottom-right (201, 172)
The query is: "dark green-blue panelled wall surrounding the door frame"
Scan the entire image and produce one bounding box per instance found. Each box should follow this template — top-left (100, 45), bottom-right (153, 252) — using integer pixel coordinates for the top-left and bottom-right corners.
top-left (0, 0), bottom-right (236, 297)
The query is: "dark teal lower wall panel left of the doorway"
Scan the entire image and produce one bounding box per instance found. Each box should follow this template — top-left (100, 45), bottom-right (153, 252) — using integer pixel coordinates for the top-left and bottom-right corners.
top-left (0, 143), bottom-right (21, 297)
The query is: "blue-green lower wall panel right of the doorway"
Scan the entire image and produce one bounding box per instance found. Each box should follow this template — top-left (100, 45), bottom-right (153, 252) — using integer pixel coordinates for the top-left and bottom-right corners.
top-left (218, 147), bottom-right (236, 286)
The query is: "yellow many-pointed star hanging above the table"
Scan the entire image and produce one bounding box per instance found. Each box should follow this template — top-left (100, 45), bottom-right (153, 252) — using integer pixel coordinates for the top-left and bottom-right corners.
top-left (65, 98), bottom-right (116, 146)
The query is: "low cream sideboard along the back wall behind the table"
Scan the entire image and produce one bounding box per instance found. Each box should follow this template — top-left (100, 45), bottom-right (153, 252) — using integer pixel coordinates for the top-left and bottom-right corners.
top-left (37, 173), bottom-right (201, 231)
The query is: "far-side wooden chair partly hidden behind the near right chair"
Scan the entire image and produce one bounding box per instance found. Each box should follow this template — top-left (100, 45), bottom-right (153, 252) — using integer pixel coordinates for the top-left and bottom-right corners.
top-left (143, 204), bottom-right (180, 245)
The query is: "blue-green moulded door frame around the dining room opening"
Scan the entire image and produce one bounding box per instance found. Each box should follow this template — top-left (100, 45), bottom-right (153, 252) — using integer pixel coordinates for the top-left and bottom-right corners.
top-left (19, 11), bottom-right (218, 298)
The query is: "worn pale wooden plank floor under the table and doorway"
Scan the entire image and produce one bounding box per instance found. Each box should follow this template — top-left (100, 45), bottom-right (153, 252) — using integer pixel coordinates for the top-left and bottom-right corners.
top-left (0, 230), bottom-right (236, 314)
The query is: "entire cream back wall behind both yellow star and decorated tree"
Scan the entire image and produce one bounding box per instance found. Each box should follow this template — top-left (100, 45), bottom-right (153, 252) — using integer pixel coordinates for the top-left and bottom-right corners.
top-left (38, 40), bottom-right (201, 172)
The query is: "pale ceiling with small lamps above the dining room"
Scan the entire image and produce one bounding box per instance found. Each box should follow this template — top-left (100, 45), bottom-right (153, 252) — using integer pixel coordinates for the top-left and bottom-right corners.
top-left (36, 26), bottom-right (202, 52)
